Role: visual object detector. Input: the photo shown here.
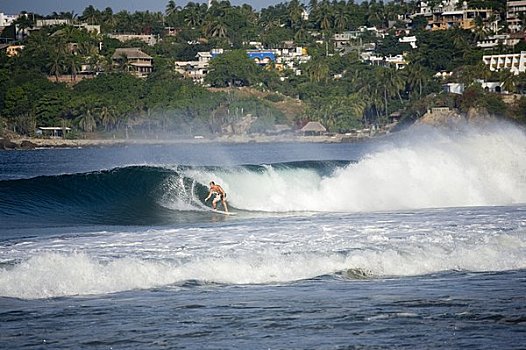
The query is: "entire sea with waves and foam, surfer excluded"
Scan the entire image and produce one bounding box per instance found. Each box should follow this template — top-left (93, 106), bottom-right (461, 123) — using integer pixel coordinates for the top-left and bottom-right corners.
top-left (0, 125), bottom-right (526, 349)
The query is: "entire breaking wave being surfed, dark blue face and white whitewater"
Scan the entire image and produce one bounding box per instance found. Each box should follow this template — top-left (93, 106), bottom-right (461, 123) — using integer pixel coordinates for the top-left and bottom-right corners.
top-left (0, 126), bottom-right (526, 227)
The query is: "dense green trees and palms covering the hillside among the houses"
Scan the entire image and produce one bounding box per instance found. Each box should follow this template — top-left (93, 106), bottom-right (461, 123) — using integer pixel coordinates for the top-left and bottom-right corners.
top-left (0, 0), bottom-right (526, 137)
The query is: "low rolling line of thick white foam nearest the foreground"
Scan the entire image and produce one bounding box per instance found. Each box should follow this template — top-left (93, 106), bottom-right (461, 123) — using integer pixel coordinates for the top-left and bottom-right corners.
top-left (0, 237), bottom-right (526, 299)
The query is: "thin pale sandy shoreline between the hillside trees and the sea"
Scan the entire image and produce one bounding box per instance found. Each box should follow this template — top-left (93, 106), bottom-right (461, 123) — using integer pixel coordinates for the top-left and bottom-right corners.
top-left (0, 134), bottom-right (372, 150)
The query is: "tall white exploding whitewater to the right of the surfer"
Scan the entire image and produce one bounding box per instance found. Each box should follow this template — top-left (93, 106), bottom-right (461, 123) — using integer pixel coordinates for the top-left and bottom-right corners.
top-left (194, 125), bottom-right (526, 212)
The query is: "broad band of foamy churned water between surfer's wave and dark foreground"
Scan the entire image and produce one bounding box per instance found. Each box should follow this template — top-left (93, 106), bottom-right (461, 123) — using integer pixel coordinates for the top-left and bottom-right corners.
top-left (0, 208), bottom-right (526, 299)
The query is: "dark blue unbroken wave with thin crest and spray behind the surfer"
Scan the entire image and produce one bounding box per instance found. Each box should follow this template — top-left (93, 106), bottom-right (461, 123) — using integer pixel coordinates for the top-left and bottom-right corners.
top-left (0, 161), bottom-right (348, 228)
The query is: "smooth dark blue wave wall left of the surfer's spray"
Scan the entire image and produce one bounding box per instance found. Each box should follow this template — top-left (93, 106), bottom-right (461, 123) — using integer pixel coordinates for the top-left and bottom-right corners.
top-left (0, 166), bottom-right (202, 226)
